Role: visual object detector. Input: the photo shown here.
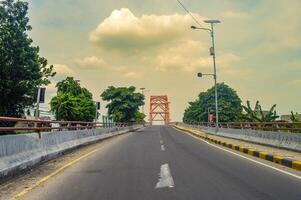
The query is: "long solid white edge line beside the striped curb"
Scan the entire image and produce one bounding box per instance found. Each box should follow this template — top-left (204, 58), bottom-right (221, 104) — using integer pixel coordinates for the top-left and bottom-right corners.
top-left (185, 131), bottom-right (301, 180)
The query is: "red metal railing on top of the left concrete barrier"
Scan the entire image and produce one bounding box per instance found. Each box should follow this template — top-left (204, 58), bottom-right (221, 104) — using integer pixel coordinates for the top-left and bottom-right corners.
top-left (0, 117), bottom-right (132, 134)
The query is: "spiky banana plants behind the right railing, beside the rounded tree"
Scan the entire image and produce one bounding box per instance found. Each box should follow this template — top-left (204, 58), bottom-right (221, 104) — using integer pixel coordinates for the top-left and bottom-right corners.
top-left (243, 101), bottom-right (279, 122)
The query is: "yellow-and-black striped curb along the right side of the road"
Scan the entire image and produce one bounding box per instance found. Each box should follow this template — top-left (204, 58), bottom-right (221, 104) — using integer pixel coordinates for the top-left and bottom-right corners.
top-left (173, 125), bottom-right (301, 171)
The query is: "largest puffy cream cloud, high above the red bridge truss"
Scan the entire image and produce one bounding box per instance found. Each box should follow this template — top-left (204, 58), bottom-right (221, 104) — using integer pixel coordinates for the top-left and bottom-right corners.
top-left (90, 8), bottom-right (203, 50)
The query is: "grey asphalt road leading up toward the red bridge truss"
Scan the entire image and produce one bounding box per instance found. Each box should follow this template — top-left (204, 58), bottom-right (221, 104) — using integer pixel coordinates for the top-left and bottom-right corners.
top-left (25, 126), bottom-right (301, 200)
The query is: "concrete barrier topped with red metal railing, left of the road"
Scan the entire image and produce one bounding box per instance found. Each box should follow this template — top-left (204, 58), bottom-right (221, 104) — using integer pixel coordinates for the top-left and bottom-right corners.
top-left (0, 117), bottom-right (143, 181)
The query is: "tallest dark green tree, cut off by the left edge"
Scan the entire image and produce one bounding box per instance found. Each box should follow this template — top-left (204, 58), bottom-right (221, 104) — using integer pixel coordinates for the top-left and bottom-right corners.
top-left (0, 0), bottom-right (55, 117)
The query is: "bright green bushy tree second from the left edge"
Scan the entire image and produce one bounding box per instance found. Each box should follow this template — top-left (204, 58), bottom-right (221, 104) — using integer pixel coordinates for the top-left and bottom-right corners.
top-left (50, 77), bottom-right (96, 122)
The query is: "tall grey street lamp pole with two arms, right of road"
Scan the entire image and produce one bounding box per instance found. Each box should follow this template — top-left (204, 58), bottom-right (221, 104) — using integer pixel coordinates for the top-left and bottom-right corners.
top-left (191, 20), bottom-right (221, 133)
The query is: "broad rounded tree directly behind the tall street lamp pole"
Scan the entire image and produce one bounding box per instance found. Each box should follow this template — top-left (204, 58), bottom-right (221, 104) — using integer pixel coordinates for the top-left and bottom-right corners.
top-left (183, 83), bottom-right (242, 123)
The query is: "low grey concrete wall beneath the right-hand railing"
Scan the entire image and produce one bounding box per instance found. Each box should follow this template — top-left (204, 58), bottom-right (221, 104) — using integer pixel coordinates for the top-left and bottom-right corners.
top-left (181, 124), bottom-right (301, 152)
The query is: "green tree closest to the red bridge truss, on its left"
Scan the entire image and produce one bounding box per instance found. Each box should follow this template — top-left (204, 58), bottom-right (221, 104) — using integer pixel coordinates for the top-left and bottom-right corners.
top-left (101, 86), bottom-right (145, 122)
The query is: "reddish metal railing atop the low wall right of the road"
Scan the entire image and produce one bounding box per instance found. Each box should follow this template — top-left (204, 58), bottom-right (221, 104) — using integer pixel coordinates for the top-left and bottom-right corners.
top-left (175, 122), bottom-right (301, 133)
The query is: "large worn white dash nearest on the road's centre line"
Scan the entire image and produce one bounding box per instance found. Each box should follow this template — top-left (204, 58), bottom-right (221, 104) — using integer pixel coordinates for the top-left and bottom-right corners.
top-left (155, 163), bottom-right (175, 189)
